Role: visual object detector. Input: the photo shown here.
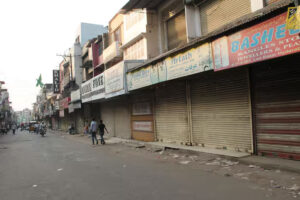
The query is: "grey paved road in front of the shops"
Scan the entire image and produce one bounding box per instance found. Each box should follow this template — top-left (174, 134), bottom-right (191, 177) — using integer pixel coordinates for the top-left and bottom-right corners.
top-left (0, 132), bottom-right (292, 200)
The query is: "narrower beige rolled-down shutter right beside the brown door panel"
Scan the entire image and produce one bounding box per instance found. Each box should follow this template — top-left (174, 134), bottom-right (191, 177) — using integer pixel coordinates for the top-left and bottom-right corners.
top-left (155, 81), bottom-right (189, 144)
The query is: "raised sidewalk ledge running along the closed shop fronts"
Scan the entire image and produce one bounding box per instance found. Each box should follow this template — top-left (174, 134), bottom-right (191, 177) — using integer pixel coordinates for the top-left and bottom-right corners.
top-left (51, 131), bottom-right (300, 174)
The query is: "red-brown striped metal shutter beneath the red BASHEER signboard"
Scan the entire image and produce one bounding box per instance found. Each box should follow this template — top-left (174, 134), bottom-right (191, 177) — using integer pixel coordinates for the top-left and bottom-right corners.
top-left (253, 55), bottom-right (300, 160)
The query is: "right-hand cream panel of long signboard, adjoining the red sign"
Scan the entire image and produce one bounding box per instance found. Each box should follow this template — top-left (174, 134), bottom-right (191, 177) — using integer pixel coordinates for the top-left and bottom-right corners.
top-left (166, 43), bottom-right (213, 80)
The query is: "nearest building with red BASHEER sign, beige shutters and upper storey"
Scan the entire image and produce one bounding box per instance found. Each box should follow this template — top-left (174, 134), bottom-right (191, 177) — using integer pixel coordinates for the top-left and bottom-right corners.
top-left (123, 0), bottom-right (300, 159)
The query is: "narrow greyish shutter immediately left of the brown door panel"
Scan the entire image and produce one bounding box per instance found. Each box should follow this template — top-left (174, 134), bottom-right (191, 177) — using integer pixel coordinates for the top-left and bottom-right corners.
top-left (115, 97), bottom-right (131, 139)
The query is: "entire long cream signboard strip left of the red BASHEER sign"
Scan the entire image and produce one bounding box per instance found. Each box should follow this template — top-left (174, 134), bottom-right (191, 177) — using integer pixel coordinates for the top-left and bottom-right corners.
top-left (127, 43), bottom-right (213, 91)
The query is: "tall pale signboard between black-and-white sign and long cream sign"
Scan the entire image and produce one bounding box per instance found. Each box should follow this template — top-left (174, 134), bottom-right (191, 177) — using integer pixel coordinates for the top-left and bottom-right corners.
top-left (105, 62), bottom-right (125, 98)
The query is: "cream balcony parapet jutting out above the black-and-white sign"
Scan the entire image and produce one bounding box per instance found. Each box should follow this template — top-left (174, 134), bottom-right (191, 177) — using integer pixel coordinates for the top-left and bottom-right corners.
top-left (103, 41), bottom-right (123, 63)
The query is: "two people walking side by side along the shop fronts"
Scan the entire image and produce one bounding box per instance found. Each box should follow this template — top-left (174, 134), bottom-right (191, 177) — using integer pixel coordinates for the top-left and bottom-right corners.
top-left (84, 118), bottom-right (108, 145)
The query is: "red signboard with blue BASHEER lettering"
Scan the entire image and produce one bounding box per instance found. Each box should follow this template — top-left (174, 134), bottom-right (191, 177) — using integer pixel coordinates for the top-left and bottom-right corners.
top-left (212, 13), bottom-right (300, 71)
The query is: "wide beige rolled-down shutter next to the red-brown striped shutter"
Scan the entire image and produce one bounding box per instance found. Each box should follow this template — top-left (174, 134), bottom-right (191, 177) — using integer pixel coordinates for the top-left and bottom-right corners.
top-left (191, 68), bottom-right (252, 152)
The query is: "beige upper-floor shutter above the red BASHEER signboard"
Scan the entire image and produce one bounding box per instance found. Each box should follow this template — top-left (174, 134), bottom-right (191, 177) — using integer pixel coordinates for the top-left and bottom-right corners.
top-left (200, 0), bottom-right (251, 34)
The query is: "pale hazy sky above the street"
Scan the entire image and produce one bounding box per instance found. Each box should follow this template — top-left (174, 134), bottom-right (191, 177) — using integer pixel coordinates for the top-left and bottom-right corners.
top-left (0, 0), bottom-right (128, 111)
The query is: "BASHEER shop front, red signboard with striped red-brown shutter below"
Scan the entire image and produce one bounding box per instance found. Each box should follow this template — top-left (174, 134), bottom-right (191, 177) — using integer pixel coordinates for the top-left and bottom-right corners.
top-left (213, 13), bottom-right (300, 160)
